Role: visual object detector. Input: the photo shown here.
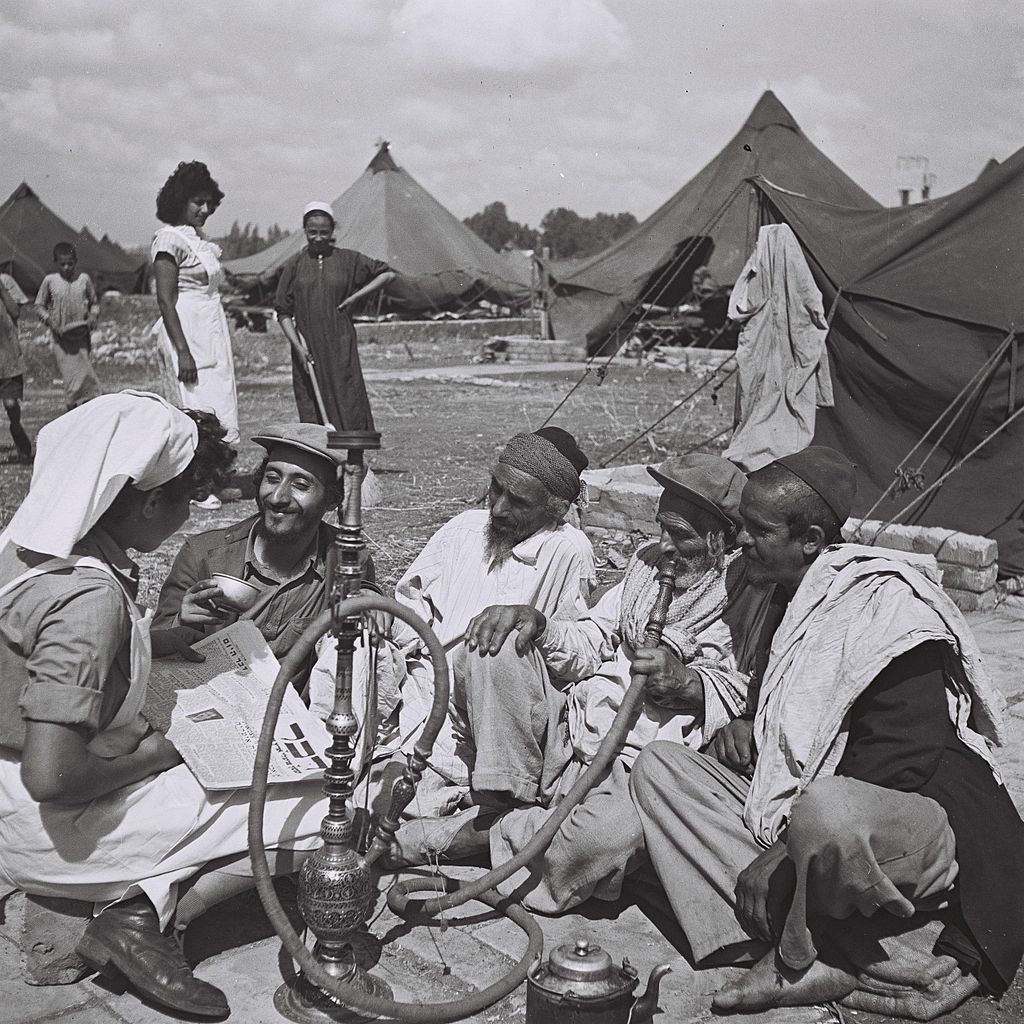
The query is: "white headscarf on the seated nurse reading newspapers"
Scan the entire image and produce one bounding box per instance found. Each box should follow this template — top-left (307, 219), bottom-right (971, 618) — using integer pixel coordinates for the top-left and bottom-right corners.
top-left (0, 390), bottom-right (199, 558)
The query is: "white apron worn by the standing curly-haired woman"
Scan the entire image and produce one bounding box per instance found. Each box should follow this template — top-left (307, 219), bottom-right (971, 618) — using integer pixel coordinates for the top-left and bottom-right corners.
top-left (153, 227), bottom-right (240, 444)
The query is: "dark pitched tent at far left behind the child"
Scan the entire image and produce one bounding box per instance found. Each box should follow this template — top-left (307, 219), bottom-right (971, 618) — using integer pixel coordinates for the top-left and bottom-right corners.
top-left (0, 181), bottom-right (145, 297)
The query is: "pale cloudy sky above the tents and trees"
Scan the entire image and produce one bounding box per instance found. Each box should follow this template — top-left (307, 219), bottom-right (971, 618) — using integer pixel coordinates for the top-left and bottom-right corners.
top-left (0, 0), bottom-right (1024, 244)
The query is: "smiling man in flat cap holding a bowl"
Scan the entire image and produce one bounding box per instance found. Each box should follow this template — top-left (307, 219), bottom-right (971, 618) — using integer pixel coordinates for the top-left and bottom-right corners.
top-left (156, 423), bottom-right (376, 687)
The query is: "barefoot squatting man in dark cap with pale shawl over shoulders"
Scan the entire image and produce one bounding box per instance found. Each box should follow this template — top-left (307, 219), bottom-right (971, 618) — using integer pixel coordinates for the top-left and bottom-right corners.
top-left (630, 446), bottom-right (1024, 1020)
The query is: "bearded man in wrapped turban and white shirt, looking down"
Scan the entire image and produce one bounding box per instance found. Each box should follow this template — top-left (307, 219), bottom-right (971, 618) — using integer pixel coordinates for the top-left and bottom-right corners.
top-left (310, 427), bottom-right (595, 802)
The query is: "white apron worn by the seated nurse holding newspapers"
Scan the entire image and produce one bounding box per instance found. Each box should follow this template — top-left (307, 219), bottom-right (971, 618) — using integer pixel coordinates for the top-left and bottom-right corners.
top-left (0, 556), bottom-right (327, 927)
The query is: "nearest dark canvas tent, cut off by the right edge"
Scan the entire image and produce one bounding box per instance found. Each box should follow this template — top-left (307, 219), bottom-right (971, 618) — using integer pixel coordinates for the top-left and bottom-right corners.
top-left (757, 150), bottom-right (1024, 575)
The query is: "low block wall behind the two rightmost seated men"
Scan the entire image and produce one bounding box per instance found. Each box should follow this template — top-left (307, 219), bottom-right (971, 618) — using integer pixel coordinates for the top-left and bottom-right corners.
top-left (580, 466), bottom-right (998, 611)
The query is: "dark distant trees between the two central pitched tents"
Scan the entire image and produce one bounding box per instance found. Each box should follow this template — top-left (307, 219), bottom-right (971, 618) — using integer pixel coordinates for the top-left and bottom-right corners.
top-left (463, 203), bottom-right (637, 259)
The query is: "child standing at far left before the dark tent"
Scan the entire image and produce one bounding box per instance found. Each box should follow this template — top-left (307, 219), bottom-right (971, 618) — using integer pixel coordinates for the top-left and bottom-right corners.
top-left (36, 242), bottom-right (103, 410)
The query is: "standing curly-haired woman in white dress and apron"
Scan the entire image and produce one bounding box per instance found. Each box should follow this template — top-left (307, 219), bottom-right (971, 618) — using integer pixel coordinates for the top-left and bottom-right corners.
top-left (150, 161), bottom-right (239, 509)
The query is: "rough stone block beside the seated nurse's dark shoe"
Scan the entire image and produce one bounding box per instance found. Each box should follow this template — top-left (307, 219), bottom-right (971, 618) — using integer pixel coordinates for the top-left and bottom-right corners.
top-left (11, 893), bottom-right (92, 985)
